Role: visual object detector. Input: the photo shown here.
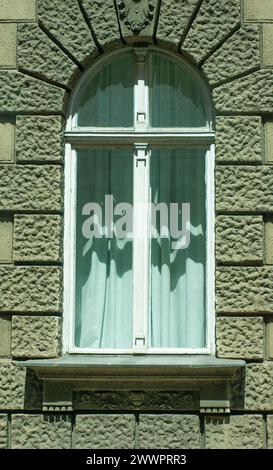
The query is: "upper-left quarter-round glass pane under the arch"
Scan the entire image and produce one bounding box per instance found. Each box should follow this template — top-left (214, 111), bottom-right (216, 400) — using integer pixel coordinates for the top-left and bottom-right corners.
top-left (78, 53), bottom-right (134, 127)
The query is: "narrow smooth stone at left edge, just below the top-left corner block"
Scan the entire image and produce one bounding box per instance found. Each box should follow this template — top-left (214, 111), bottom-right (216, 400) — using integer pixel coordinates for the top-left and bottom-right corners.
top-left (0, 23), bottom-right (16, 68)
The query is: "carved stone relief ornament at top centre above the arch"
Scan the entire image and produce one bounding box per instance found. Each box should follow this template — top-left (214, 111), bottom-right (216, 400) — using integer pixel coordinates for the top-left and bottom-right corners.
top-left (117, 0), bottom-right (156, 35)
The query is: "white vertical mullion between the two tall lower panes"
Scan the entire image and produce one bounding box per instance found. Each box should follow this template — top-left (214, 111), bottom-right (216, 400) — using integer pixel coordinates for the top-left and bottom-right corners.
top-left (133, 144), bottom-right (150, 354)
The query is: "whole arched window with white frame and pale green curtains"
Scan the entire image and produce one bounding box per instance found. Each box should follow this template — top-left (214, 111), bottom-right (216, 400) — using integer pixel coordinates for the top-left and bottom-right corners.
top-left (65, 47), bottom-right (214, 354)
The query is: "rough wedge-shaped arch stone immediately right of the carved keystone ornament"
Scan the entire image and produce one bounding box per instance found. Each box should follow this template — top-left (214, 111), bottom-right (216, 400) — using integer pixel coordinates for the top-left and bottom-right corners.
top-left (157, 0), bottom-right (199, 44)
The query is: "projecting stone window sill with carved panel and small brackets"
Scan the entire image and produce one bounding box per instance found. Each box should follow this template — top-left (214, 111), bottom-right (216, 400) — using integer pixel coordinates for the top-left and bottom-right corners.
top-left (17, 355), bottom-right (245, 416)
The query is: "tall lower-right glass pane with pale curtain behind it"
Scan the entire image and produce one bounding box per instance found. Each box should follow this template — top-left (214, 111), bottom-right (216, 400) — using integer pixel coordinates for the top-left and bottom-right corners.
top-left (149, 150), bottom-right (206, 348)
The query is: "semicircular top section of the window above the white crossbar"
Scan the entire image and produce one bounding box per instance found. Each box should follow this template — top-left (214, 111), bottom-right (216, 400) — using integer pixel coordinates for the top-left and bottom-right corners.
top-left (68, 48), bottom-right (212, 131)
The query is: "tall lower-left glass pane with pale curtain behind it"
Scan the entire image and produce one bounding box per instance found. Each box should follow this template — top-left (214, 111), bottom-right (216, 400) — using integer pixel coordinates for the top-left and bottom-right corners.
top-left (75, 150), bottom-right (133, 348)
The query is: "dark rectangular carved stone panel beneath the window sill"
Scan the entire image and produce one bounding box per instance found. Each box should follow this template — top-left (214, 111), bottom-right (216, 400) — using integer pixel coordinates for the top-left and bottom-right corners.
top-left (74, 390), bottom-right (200, 411)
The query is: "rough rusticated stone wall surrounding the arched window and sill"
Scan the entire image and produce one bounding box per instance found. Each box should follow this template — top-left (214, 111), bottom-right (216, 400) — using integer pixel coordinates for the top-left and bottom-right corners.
top-left (0, 0), bottom-right (273, 448)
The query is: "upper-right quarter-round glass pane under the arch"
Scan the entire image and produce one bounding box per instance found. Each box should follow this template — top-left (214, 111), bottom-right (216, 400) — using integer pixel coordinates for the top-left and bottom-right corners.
top-left (150, 53), bottom-right (208, 127)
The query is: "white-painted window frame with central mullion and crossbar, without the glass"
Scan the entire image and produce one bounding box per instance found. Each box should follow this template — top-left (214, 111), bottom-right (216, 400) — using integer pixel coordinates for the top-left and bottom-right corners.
top-left (63, 46), bottom-right (215, 355)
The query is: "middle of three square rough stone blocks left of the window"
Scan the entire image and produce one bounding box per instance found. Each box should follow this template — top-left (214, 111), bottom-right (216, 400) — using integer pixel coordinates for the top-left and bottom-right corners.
top-left (13, 215), bottom-right (62, 262)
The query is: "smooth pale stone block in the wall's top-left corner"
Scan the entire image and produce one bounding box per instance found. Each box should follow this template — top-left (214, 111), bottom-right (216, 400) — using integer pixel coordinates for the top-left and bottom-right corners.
top-left (0, 0), bottom-right (36, 21)
